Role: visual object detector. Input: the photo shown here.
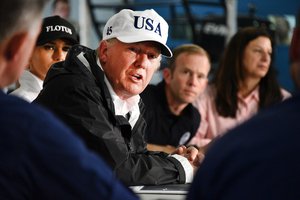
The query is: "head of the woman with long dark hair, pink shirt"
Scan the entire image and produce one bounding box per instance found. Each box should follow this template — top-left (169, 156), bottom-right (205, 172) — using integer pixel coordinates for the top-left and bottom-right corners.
top-left (216, 27), bottom-right (273, 84)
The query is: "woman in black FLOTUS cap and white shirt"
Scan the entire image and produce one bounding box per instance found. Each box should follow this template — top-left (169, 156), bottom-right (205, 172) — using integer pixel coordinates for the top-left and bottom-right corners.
top-left (10, 16), bottom-right (78, 102)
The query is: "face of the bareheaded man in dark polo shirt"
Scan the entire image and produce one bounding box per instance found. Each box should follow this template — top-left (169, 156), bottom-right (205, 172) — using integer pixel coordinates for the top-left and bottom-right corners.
top-left (164, 53), bottom-right (210, 104)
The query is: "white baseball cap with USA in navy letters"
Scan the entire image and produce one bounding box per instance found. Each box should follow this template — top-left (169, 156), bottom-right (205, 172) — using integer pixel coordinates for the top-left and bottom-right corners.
top-left (103, 9), bottom-right (172, 57)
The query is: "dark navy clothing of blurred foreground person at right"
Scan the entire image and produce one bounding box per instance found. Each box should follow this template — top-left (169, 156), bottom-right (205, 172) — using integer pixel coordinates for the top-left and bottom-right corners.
top-left (188, 93), bottom-right (300, 200)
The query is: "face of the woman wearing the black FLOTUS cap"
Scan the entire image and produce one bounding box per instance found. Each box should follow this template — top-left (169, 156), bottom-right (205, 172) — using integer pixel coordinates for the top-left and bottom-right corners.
top-left (29, 39), bottom-right (71, 80)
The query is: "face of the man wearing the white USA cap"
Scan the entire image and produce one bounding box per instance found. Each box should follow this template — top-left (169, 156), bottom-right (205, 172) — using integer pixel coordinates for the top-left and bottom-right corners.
top-left (99, 40), bottom-right (161, 99)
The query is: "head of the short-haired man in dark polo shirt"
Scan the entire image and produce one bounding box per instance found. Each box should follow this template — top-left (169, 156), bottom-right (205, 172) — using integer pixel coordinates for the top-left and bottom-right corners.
top-left (163, 44), bottom-right (210, 104)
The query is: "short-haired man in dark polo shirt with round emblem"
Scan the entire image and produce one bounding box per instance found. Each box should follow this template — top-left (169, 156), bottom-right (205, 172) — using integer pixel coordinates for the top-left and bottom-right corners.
top-left (141, 44), bottom-right (210, 153)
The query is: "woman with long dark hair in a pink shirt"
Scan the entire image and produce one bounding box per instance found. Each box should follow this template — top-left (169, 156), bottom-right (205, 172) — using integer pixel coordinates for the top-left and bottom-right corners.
top-left (190, 27), bottom-right (291, 147)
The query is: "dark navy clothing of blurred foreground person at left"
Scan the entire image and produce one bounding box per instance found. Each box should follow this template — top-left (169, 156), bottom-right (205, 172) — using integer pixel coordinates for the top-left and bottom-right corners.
top-left (0, 91), bottom-right (137, 200)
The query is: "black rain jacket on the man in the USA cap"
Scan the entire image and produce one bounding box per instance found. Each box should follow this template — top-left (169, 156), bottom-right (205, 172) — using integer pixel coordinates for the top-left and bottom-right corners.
top-left (34, 45), bottom-right (185, 185)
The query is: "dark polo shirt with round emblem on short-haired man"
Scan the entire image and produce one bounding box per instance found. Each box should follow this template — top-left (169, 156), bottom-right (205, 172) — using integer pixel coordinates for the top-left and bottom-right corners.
top-left (140, 81), bottom-right (200, 147)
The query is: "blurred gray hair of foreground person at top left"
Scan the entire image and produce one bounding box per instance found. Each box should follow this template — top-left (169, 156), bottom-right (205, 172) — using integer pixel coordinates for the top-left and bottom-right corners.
top-left (0, 0), bottom-right (48, 42)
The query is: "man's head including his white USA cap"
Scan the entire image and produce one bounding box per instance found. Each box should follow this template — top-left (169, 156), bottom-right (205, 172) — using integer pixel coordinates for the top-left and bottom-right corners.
top-left (98, 9), bottom-right (172, 99)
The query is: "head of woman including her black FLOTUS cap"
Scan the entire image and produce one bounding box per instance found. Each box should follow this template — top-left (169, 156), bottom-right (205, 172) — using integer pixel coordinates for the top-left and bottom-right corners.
top-left (29, 16), bottom-right (78, 80)
